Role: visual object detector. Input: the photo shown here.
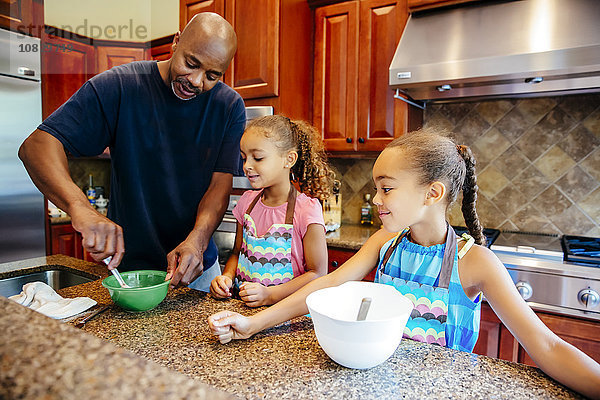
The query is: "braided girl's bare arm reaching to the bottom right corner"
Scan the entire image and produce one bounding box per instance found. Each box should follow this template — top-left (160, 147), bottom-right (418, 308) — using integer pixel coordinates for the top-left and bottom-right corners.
top-left (460, 246), bottom-right (600, 398)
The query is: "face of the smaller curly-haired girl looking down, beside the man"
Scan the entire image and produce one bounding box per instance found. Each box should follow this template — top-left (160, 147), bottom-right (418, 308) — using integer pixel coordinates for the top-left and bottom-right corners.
top-left (240, 128), bottom-right (290, 189)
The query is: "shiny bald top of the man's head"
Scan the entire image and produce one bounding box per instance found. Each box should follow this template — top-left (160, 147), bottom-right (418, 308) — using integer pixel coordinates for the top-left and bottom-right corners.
top-left (179, 12), bottom-right (237, 65)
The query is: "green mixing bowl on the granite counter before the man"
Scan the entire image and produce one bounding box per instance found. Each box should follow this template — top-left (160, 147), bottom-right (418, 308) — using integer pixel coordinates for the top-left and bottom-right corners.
top-left (102, 270), bottom-right (171, 311)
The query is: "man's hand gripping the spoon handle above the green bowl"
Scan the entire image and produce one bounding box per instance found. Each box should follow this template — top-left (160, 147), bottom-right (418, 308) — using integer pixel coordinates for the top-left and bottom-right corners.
top-left (71, 207), bottom-right (125, 269)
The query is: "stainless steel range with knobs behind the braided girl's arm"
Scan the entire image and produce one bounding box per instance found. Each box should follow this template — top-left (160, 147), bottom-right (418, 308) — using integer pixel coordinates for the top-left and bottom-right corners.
top-left (491, 232), bottom-right (600, 320)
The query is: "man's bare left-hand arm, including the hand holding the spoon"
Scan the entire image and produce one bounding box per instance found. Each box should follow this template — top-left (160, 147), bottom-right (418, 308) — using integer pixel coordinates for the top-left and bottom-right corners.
top-left (19, 129), bottom-right (125, 269)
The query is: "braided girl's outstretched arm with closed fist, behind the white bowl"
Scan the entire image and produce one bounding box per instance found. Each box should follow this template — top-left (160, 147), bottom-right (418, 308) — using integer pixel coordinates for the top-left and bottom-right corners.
top-left (208, 229), bottom-right (395, 343)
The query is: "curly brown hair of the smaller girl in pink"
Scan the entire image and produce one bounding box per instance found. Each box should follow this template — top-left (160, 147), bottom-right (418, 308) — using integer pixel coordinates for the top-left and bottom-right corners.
top-left (246, 115), bottom-right (334, 200)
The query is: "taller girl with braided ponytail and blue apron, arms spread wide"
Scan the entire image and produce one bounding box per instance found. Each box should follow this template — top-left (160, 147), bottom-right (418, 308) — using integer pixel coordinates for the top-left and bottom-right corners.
top-left (208, 129), bottom-right (600, 398)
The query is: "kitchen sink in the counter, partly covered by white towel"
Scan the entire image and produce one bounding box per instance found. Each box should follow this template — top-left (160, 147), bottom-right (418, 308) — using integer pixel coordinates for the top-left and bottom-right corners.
top-left (0, 269), bottom-right (96, 297)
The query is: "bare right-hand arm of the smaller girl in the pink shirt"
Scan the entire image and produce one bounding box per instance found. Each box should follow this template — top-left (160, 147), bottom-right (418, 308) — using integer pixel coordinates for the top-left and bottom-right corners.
top-left (251, 224), bottom-right (327, 307)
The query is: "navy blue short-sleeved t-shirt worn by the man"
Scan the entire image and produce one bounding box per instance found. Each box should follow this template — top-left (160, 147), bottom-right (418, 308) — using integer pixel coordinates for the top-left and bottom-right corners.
top-left (39, 61), bottom-right (246, 270)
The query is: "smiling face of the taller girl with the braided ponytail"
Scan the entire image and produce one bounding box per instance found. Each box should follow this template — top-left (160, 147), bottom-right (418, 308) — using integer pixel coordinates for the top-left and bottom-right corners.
top-left (373, 148), bottom-right (428, 232)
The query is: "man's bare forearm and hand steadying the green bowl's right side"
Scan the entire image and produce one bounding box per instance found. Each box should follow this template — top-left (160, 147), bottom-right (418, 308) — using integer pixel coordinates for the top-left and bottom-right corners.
top-left (166, 172), bottom-right (233, 287)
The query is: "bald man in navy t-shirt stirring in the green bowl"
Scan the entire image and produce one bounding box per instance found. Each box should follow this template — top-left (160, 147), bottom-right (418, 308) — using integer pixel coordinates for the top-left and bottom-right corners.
top-left (19, 13), bottom-right (246, 291)
